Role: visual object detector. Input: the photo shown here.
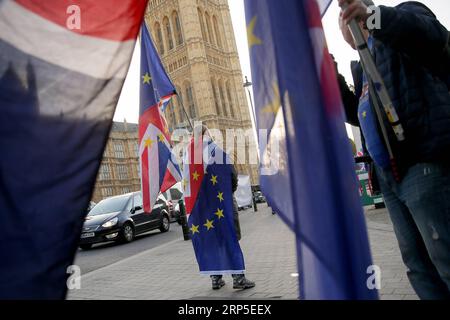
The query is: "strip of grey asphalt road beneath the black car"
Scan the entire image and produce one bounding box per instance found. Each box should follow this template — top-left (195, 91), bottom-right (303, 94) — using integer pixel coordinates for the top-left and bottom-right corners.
top-left (74, 222), bottom-right (183, 275)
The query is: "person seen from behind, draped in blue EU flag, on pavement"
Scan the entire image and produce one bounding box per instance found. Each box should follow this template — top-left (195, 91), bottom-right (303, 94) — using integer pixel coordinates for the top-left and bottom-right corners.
top-left (183, 126), bottom-right (254, 289)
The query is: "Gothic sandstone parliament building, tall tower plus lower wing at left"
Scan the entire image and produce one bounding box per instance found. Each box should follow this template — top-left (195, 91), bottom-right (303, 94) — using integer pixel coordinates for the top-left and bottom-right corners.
top-left (93, 0), bottom-right (258, 202)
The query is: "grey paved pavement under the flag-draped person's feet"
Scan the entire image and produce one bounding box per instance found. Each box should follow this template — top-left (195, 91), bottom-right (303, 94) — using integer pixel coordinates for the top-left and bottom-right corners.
top-left (67, 204), bottom-right (418, 300)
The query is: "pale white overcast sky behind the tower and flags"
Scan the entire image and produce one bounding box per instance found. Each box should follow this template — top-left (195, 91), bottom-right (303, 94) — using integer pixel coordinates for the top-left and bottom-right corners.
top-left (114, 0), bottom-right (450, 123)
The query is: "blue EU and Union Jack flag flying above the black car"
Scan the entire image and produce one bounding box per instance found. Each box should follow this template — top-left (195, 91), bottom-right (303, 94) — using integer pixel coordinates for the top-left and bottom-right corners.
top-left (139, 23), bottom-right (181, 213)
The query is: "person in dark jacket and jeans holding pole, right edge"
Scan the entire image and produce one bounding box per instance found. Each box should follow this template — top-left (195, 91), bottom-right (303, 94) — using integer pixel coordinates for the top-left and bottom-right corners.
top-left (338, 0), bottom-right (450, 299)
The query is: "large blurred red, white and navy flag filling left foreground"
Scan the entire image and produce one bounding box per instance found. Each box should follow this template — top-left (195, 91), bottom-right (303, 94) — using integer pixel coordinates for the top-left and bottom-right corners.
top-left (0, 0), bottom-right (147, 300)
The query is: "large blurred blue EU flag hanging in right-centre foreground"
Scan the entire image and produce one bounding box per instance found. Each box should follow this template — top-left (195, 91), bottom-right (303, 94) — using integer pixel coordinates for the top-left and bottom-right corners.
top-left (245, 0), bottom-right (378, 299)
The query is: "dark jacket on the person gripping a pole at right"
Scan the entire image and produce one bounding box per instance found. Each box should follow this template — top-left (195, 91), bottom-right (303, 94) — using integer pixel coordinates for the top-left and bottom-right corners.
top-left (339, 1), bottom-right (450, 172)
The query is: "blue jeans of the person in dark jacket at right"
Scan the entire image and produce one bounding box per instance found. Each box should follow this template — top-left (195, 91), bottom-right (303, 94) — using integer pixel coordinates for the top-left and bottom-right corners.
top-left (377, 163), bottom-right (450, 299)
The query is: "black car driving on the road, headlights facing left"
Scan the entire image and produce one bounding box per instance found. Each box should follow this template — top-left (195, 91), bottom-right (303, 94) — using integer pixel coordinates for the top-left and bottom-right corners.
top-left (79, 192), bottom-right (170, 250)
